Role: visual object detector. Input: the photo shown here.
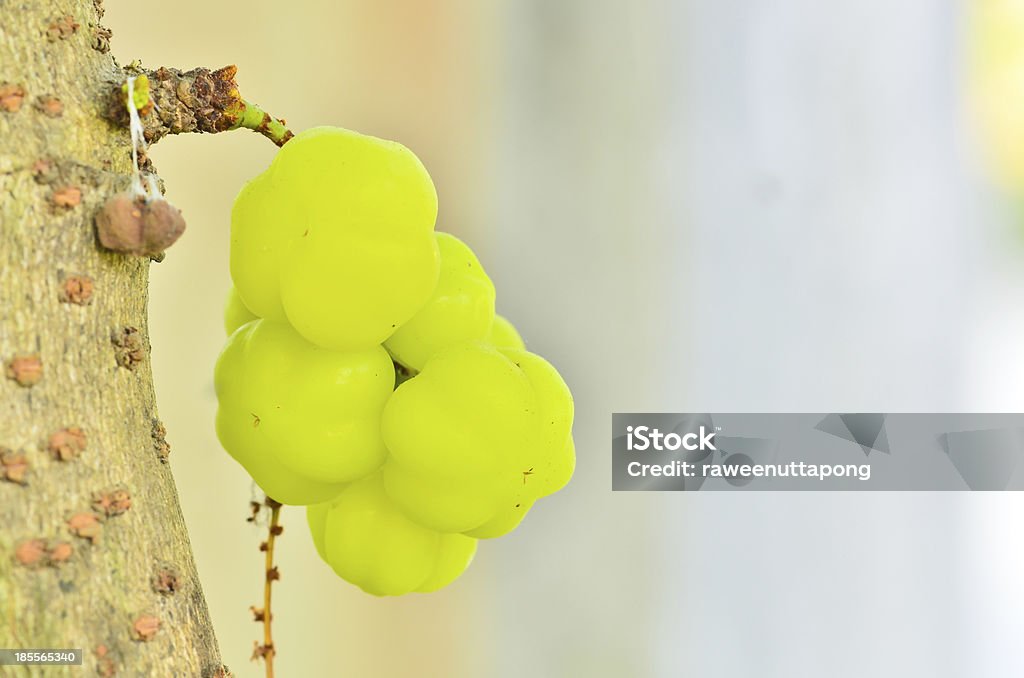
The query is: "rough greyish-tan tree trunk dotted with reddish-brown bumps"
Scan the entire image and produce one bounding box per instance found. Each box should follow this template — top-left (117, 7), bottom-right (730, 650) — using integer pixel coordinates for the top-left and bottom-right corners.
top-left (0, 0), bottom-right (226, 676)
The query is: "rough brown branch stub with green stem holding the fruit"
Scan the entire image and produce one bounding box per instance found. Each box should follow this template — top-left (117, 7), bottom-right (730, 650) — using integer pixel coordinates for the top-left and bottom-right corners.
top-left (106, 66), bottom-right (292, 145)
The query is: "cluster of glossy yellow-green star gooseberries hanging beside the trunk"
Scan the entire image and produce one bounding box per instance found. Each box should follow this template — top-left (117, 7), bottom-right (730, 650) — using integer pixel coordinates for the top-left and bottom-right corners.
top-left (215, 127), bottom-right (575, 595)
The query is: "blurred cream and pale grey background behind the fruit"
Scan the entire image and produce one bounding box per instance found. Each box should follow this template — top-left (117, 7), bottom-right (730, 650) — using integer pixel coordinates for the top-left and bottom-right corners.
top-left (105, 0), bottom-right (1024, 678)
